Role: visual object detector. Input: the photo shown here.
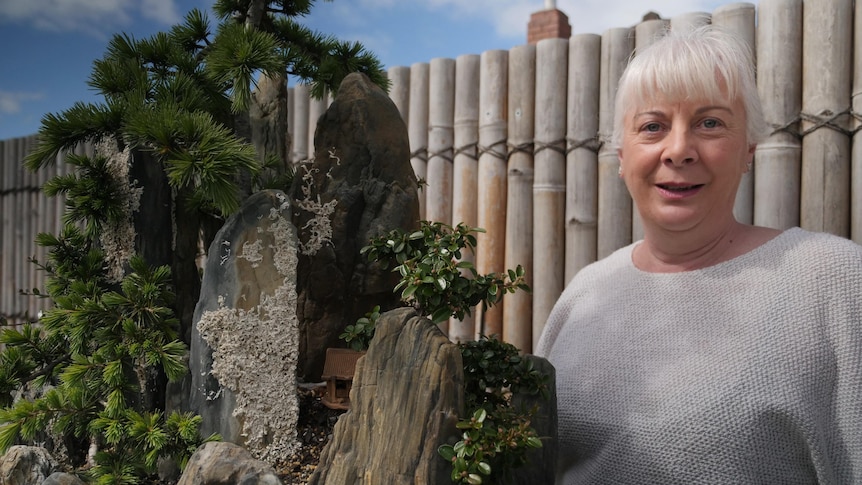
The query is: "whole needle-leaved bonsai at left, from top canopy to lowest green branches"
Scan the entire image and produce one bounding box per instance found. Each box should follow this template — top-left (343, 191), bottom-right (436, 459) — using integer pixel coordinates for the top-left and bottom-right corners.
top-left (0, 0), bottom-right (387, 483)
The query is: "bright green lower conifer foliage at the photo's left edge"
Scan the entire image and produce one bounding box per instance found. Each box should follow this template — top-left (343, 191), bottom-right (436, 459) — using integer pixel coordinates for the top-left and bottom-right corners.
top-left (0, 225), bottom-right (218, 484)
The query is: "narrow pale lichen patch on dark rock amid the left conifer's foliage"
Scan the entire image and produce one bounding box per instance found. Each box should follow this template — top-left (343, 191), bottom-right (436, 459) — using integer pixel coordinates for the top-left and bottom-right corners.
top-left (95, 138), bottom-right (144, 282)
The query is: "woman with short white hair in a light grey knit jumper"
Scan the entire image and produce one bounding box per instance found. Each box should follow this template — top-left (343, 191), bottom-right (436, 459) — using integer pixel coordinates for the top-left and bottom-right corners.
top-left (536, 27), bottom-right (862, 485)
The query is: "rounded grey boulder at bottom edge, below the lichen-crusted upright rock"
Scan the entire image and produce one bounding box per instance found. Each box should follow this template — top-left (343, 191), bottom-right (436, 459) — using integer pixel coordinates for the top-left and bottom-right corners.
top-left (177, 442), bottom-right (282, 485)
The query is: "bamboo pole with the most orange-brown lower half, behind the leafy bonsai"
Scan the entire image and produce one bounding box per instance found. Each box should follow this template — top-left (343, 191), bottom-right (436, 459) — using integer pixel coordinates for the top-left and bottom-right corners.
top-left (476, 50), bottom-right (509, 338)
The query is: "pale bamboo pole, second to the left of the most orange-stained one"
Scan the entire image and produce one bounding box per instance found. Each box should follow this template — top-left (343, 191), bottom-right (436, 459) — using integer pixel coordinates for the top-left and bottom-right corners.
top-left (425, 57), bottom-right (455, 224)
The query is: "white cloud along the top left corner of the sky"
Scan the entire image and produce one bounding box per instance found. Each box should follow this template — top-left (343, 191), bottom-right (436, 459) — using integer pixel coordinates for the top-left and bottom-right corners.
top-left (0, 0), bottom-right (181, 37)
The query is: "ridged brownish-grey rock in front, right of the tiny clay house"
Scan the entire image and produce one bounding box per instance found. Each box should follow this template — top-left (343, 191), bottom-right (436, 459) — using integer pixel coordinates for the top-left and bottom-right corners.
top-left (308, 308), bottom-right (464, 485)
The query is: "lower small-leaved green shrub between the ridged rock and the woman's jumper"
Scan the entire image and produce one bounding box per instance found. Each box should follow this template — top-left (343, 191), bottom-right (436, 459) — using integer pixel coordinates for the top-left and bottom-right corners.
top-left (437, 337), bottom-right (548, 485)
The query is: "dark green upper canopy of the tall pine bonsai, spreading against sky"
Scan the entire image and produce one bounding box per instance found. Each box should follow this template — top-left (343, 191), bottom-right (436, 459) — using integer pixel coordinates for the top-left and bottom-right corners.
top-left (25, 0), bottom-right (388, 341)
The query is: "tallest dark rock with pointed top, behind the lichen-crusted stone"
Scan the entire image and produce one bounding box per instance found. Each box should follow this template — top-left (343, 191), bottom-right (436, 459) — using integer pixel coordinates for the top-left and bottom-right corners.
top-left (291, 73), bottom-right (419, 382)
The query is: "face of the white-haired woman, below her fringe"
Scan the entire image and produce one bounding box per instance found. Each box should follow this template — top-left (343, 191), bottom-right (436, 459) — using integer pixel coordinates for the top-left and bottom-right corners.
top-left (618, 94), bottom-right (755, 232)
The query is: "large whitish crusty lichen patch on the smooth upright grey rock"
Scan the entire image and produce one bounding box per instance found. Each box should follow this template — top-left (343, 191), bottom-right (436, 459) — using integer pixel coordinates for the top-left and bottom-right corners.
top-left (197, 195), bottom-right (299, 463)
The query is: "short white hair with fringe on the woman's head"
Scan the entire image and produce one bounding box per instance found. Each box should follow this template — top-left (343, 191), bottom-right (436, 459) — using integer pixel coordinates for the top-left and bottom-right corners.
top-left (612, 25), bottom-right (768, 147)
